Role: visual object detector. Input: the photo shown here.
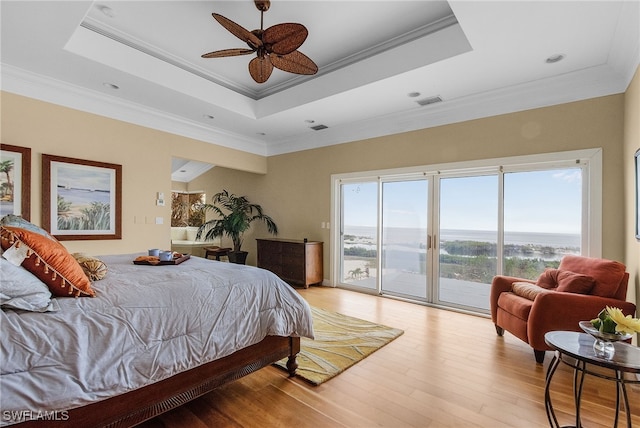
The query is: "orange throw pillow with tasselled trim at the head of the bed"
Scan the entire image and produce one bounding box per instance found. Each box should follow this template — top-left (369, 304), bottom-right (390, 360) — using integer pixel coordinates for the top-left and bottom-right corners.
top-left (0, 226), bottom-right (95, 297)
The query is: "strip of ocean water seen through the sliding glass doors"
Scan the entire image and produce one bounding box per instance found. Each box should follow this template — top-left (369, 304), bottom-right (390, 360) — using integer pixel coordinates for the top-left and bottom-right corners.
top-left (344, 225), bottom-right (580, 250)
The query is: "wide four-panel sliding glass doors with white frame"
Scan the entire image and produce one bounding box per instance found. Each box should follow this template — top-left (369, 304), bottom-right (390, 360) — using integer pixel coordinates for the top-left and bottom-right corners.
top-left (331, 149), bottom-right (602, 313)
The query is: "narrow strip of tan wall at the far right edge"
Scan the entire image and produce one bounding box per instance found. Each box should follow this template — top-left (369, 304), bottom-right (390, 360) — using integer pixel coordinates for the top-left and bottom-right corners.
top-left (623, 68), bottom-right (640, 312)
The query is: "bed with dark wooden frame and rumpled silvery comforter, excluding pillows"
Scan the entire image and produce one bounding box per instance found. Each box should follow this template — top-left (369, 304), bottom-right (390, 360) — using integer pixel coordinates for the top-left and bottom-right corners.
top-left (0, 254), bottom-right (313, 427)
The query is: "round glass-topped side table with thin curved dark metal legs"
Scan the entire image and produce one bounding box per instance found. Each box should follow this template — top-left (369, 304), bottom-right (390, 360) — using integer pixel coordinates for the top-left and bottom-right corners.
top-left (544, 331), bottom-right (640, 428)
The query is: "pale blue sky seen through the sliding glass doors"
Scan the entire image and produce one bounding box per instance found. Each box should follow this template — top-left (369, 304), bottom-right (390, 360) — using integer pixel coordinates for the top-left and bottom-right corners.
top-left (343, 168), bottom-right (582, 234)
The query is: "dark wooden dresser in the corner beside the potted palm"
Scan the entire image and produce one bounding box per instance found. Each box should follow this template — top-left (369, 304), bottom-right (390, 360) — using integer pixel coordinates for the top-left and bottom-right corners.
top-left (256, 239), bottom-right (323, 288)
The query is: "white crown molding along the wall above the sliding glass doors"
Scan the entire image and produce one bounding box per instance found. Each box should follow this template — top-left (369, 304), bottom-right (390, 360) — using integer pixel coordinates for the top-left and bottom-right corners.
top-left (267, 64), bottom-right (629, 156)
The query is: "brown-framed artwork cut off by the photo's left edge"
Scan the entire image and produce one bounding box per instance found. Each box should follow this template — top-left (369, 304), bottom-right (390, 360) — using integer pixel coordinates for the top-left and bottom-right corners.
top-left (0, 144), bottom-right (31, 220)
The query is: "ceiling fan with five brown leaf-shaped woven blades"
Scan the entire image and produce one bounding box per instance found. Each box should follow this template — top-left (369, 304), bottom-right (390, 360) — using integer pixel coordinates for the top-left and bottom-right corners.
top-left (202, 0), bottom-right (318, 83)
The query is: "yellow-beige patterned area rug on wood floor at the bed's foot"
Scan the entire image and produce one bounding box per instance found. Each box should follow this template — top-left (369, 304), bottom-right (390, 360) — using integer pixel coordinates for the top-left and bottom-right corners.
top-left (275, 307), bottom-right (404, 385)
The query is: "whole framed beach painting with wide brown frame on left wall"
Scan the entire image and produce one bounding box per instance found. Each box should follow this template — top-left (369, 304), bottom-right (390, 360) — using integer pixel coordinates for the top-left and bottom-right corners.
top-left (42, 154), bottom-right (122, 241)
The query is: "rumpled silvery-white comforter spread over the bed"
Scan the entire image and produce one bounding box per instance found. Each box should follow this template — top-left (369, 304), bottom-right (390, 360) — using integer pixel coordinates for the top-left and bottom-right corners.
top-left (0, 254), bottom-right (313, 425)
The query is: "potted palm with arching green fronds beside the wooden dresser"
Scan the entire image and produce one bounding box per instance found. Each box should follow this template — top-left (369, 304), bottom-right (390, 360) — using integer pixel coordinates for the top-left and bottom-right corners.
top-left (196, 190), bottom-right (278, 264)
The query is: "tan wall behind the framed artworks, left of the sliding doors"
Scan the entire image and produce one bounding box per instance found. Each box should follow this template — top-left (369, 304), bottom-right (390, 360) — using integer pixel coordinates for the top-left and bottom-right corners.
top-left (0, 92), bottom-right (266, 255)
